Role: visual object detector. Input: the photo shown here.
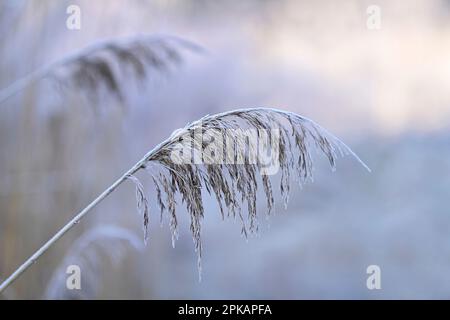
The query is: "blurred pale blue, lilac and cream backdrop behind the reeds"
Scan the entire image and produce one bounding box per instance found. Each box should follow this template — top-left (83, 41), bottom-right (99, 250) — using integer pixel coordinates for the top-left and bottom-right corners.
top-left (0, 0), bottom-right (450, 299)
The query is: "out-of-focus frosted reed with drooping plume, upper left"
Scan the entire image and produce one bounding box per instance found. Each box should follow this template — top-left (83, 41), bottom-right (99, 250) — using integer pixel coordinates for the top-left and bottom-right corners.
top-left (0, 35), bottom-right (203, 103)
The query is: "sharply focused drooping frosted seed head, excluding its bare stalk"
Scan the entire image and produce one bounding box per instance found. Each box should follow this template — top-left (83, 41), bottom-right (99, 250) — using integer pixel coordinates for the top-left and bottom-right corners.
top-left (126, 108), bottom-right (370, 278)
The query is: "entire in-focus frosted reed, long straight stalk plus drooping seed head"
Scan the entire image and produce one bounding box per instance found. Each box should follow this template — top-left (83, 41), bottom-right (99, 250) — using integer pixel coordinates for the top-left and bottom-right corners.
top-left (0, 108), bottom-right (370, 292)
